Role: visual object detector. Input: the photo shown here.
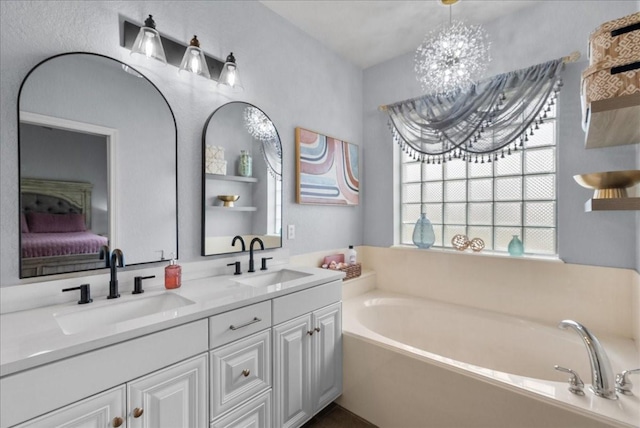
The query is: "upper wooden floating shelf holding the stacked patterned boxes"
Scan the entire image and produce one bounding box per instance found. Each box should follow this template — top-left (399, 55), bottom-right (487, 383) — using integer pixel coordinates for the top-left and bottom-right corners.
top-left (585, 92), bottom-right (640, 149)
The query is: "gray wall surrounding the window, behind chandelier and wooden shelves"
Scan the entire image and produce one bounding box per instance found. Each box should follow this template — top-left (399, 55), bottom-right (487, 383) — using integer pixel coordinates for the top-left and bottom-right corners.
top-left (363, 1), bottom-right (640, 269)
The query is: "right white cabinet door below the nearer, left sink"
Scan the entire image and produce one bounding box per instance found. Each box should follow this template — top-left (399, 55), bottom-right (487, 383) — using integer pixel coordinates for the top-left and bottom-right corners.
top-left (127, 354), bottom-right (207, 428)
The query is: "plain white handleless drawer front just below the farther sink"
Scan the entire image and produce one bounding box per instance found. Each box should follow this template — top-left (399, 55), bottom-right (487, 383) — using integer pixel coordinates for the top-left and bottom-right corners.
top-left (273, 280), bottom-right (342, 325)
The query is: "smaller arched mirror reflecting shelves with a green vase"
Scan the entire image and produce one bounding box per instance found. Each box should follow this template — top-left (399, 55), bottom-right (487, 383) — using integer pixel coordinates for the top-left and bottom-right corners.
top-left (202, 102), bottom-right (282, 256)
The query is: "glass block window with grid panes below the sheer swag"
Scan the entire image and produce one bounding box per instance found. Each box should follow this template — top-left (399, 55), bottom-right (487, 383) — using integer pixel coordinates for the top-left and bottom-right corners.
top-left (400, 106), bottom-right (557, 256)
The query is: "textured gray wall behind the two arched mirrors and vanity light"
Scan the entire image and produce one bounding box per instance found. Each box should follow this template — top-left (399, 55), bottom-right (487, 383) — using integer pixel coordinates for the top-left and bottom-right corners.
top-left (0, 1), bottom-right (363, 285)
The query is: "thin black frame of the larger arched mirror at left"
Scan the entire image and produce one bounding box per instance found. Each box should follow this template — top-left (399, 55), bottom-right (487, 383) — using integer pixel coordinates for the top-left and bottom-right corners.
top-left (16, 51), bottom-right (180, 280)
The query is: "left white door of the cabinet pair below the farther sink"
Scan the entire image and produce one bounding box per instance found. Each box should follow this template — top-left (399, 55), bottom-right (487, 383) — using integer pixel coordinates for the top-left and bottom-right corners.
top-left (273, 315), bottom-right (313, 428)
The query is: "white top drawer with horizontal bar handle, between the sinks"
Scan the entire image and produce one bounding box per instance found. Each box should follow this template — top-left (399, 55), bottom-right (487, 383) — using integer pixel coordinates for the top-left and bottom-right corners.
top-left (209, 301), bottom-right (271, 349)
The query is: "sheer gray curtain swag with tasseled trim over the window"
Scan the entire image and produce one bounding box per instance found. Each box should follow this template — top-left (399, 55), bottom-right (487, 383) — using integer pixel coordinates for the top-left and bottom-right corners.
top-left (387, 59), bottom-right (564, 163)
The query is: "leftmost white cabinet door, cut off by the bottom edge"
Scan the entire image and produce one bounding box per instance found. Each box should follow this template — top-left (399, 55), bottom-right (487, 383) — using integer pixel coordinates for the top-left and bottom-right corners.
top-left (15, 385), bottom-right (127, 428)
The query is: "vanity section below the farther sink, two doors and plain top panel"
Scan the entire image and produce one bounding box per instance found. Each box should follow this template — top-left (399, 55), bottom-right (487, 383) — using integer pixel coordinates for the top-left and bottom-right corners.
top-left (273, 283), bottom-right (342, 428)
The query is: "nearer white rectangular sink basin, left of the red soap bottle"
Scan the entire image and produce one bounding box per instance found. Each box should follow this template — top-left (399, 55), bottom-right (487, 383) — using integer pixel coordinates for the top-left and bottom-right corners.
top-left (53, 293), bottom-right (195, 335)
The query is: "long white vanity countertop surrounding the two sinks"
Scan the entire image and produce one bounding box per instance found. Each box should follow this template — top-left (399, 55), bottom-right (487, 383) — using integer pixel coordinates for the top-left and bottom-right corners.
top-left (0, 266), bottom-right (344, 376)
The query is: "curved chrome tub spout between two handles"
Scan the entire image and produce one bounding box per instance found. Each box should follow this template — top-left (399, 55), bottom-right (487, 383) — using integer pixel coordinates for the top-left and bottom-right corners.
top-left (558, 320), bottom-right (618, 400)
